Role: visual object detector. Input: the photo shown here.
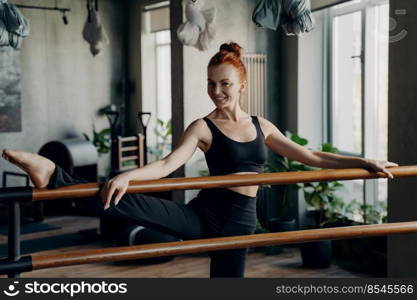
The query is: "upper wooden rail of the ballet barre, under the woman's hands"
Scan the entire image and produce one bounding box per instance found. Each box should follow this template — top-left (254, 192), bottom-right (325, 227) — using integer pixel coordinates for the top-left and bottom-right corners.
top-left (0, 165), bottom-right (417, 202)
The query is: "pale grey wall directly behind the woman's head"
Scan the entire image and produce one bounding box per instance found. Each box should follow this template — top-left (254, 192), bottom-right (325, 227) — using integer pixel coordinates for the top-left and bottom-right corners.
top-left (184, 0), bottom-right (279, 201)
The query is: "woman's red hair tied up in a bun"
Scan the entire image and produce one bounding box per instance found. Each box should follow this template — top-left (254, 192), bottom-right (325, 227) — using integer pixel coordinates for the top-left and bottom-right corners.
top-left (207, 42), bottom-right (247, 82)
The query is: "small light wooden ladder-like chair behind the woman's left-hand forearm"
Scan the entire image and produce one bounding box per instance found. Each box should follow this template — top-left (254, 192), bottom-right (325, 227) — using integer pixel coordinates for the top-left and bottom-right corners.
top-left (116, 134), bottom-right (145, 172)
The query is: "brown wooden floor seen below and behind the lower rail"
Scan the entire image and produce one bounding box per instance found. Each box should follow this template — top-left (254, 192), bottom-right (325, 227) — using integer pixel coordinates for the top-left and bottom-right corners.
top-left (0, 217), bottom-right (369, 278)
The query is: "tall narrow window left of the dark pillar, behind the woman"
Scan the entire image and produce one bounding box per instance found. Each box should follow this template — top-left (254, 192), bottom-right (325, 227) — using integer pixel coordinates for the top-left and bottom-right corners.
top-left (141, 1), bottom-right (171, 162)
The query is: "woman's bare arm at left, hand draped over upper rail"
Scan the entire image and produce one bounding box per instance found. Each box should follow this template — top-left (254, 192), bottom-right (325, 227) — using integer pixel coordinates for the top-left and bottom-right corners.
top-left (101, 119), bottom-right (204, 209)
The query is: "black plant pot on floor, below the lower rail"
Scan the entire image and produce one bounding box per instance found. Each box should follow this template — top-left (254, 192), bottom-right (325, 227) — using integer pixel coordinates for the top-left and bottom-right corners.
top-left (300, 240), bottom-right (332, 269)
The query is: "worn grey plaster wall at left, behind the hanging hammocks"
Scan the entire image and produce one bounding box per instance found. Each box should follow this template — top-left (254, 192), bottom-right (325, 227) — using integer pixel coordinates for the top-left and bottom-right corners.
top-left (0, 0), bottom-right (124, 183)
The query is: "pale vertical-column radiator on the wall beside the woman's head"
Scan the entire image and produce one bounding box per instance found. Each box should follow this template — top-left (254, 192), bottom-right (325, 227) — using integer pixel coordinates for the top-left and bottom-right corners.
top-left (241, 53), bottom-right (267, 117)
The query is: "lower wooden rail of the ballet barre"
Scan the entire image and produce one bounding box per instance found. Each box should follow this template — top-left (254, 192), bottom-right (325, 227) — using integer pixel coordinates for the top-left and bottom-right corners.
top-left (32, 222), bottom-right (417, 270)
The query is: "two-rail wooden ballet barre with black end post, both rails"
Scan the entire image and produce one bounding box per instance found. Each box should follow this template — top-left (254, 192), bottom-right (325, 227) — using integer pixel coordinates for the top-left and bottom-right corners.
top-left (0, 166), bottom-right (417, 277)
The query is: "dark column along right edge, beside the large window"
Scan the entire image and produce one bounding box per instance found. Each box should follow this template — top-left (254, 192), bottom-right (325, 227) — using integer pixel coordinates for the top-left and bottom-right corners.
top-left (388, 0), bottom-right (417, 277)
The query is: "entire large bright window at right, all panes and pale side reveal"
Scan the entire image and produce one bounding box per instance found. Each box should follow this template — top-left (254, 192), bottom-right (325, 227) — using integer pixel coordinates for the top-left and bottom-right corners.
top-left (298, 0), bottom-right (389, 223)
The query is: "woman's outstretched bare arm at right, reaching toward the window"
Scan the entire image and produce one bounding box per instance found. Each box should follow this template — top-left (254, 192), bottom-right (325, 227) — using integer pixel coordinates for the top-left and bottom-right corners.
top-left (259, 118), bottom-right (398, 178)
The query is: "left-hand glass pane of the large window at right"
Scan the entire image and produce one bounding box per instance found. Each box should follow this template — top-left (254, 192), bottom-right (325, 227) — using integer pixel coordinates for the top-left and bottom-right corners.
top-left (330, 11), bottom-right (363, 155)
